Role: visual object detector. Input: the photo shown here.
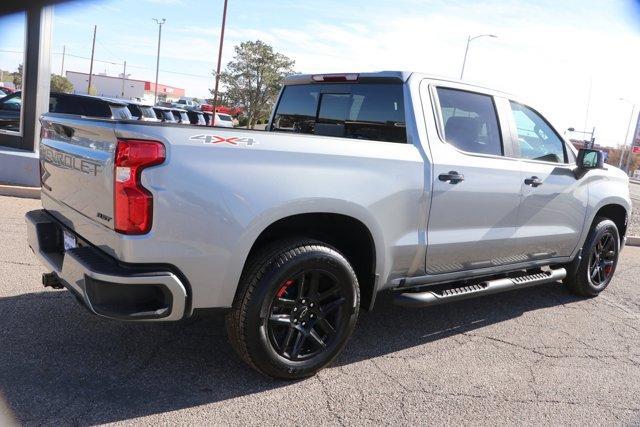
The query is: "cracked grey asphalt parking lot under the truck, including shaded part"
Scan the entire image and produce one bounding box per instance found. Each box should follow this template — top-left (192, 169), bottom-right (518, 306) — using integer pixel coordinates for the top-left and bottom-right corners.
top-left (0, 197), bottom-right (640, 425)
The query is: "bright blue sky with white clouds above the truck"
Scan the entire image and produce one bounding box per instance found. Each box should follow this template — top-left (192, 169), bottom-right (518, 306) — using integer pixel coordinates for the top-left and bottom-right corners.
top-left (0, 0), bottom-right (640, 146)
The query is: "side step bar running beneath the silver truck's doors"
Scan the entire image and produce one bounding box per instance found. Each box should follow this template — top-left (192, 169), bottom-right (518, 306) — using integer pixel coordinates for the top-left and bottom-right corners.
top-left (394, 268), bottom-right (567, 307)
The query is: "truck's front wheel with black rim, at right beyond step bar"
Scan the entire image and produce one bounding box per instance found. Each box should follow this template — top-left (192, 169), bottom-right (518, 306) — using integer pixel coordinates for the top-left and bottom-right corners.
top-left (563, 217), bottom-right (620, 297)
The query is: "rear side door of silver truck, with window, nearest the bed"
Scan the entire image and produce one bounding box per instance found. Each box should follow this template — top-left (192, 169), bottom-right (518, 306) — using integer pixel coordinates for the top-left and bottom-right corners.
top-left (423, 83), bottom-right (523, 274)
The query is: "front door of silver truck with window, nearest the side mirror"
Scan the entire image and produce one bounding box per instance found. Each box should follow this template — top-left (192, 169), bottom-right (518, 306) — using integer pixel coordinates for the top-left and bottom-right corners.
top-left (509, 101), bottom-right (588, 259)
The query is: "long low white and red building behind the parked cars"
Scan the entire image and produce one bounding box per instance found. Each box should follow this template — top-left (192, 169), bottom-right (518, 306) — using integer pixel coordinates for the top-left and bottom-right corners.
top-left (66, 71), bottom-right (184, 103)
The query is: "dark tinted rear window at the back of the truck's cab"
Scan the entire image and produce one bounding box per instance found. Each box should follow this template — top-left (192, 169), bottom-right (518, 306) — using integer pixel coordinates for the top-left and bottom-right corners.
top-left (272, 83), bottom-right (407, 142)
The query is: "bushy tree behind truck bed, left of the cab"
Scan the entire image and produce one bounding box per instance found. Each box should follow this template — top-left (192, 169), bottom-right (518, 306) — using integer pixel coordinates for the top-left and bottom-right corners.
top-left (212, 40), bottom-right (295, 129)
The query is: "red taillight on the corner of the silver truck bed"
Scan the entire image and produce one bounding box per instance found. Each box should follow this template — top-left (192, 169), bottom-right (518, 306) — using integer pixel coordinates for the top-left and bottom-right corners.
top-left (114, 139), bottom-right (165, 234)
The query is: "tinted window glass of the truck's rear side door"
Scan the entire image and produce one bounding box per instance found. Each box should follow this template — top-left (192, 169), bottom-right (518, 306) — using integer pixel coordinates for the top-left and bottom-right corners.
top-left (437, 87), bottom-right (503, 156)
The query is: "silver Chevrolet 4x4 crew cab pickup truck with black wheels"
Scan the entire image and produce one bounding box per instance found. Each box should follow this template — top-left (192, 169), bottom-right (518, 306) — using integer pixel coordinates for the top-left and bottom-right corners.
top-left (26, 72), bottom-right (631, 379)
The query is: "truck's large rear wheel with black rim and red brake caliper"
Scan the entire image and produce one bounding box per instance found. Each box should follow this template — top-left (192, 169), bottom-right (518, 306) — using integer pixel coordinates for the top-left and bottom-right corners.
top-left (226, 240), bottom-right (360, 379)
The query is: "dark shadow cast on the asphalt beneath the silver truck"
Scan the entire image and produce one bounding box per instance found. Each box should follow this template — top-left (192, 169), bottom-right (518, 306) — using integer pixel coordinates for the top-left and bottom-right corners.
top-left (0, 284), bottom-right (578, 424)
